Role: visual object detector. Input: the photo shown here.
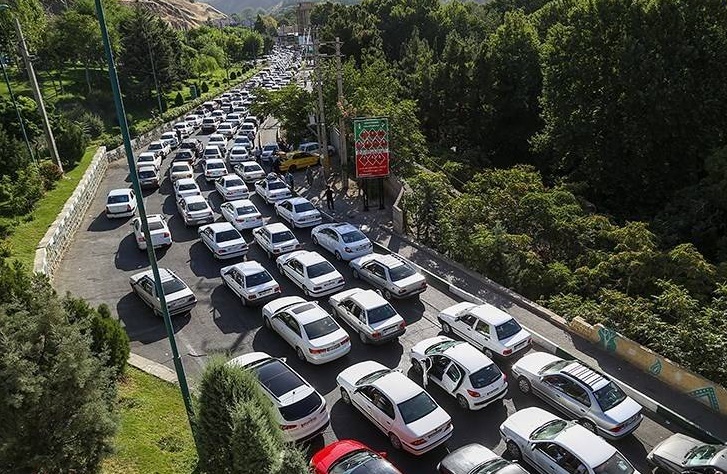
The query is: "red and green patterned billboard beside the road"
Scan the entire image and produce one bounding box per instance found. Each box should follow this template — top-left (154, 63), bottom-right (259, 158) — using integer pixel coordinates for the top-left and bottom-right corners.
top-left (353, 117), bottom-right (389, 178)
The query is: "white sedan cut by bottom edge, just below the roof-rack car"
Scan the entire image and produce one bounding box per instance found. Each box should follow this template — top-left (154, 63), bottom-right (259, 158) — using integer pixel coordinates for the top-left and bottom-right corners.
top-left (500, 407), bottom-right (638, 474)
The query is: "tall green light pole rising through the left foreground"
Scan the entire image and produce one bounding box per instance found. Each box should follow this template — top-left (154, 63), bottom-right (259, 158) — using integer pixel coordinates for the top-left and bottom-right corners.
top-left (95, 0), bottom-right (197, 450)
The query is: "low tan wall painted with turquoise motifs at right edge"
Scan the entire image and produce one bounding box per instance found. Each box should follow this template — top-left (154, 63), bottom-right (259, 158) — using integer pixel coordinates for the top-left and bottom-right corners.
top-left (569, 317), bottom-right (727, 415)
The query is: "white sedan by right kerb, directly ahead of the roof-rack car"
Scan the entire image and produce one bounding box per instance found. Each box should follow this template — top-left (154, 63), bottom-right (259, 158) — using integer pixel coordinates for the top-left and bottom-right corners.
top-left (438, 302), bottom-right (531, 359)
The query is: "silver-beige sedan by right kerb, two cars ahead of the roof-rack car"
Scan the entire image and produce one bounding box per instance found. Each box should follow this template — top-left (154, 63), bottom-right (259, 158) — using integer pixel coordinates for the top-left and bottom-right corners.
top-left (349, 253), bottom-right (427, 300)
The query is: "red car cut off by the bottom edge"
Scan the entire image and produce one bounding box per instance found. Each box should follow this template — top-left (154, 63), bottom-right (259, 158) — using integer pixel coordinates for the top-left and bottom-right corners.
top-left (310, 439), bottom-right (401, 474)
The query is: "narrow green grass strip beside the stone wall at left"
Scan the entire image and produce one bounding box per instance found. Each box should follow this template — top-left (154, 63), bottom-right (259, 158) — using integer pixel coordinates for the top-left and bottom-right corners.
top-left (8, 143), bottom-right (98, 270)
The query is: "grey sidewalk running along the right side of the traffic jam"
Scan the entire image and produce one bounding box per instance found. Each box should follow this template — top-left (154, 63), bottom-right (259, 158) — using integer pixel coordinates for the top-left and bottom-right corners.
top-left (298, 166), bottom-right (727, 440)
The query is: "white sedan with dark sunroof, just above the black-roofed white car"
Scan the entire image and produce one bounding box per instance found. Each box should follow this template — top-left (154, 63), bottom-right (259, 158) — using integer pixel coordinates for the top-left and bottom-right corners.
top-left (263, 296), bottom-right (351, 364)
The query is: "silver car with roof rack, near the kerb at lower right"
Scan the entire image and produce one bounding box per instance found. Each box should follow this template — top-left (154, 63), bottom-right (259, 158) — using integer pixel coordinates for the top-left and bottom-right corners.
top-left (512, 352), bottom-right (643, 440)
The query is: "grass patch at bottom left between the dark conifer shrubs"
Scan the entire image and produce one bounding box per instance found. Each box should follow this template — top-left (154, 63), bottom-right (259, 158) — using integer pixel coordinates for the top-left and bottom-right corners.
top-left (102, 367), bottom-right (197, 474)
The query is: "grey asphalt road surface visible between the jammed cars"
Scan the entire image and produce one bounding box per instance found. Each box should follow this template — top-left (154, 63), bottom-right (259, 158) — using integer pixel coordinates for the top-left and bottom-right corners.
top-left (55, 113), bottom-right (671, 474)
